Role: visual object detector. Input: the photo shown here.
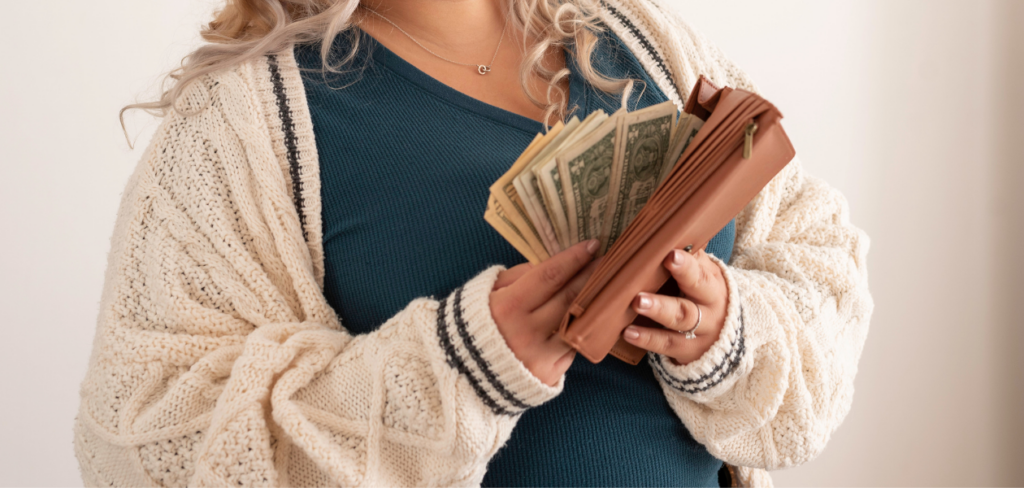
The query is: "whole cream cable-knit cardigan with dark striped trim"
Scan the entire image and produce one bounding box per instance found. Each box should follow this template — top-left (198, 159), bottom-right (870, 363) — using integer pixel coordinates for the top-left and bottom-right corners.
top-left (75, 0), bottom-right (872, 486)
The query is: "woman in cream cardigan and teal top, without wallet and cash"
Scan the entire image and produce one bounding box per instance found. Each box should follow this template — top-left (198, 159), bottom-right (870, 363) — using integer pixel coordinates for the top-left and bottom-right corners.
top-left (75, 0), bottom-right (872, 486)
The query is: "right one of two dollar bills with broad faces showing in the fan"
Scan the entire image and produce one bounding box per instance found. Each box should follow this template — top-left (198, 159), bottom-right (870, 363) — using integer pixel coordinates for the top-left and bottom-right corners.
top-left (601, 101), bottom-right (676, 252)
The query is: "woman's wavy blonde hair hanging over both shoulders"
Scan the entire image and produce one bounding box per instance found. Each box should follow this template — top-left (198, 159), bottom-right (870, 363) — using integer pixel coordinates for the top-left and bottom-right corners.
top-left (121, 0), bottom-right (633, 141)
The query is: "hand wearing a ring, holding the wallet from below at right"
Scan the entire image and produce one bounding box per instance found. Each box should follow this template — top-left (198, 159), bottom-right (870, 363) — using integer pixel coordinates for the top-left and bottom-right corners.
top-left (623, 249), bottom-right (729, 364)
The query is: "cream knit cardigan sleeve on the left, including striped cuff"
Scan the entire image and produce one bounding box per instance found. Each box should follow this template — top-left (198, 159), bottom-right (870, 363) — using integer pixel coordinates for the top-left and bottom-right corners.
top-left (75, 75), bottom-right (562, 486)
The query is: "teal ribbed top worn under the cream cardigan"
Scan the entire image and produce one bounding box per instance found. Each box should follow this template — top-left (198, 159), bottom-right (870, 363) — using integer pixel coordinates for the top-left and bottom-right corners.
top-left (296, 27), bottom-right (734, 486)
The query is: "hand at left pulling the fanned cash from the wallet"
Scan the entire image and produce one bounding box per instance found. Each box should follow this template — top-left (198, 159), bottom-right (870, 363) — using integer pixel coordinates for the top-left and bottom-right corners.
top-left (490, 239), bottom-right (599, 386)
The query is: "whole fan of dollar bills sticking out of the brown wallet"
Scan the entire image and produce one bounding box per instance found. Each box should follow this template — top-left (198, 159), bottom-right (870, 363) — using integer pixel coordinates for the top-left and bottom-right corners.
top-left (483, 101), bottom-right (703, 263)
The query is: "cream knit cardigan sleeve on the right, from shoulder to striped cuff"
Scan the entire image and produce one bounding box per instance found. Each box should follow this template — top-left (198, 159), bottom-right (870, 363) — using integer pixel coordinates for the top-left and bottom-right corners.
top-left (648, 6), bottom-right (873, 470)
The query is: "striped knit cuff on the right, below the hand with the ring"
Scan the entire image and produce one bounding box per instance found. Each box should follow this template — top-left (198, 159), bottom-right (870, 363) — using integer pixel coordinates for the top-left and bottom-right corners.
top-left (647, 255), bottom-right (746, 403)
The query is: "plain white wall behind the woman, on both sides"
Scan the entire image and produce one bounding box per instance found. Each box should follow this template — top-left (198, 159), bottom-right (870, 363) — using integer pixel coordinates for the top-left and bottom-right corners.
top-left (0, 0), bottom-right (1024, 486)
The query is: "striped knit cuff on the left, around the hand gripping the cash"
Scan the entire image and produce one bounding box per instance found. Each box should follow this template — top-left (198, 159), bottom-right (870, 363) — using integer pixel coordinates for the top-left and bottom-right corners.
top-left (437, 266), bottom-right (565, 416)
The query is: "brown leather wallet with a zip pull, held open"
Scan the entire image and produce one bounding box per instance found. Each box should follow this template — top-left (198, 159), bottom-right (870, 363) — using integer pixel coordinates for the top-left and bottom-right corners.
top-left (558, 76), bottom-right (796, 364)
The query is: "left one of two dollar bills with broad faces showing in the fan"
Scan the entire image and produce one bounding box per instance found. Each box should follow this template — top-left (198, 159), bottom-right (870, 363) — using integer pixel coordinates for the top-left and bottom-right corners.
top-left (555, 113), bottom-right (623, 245)
